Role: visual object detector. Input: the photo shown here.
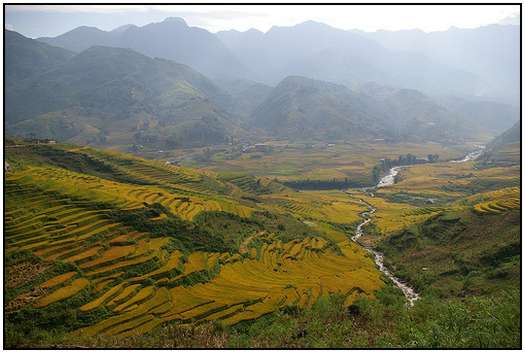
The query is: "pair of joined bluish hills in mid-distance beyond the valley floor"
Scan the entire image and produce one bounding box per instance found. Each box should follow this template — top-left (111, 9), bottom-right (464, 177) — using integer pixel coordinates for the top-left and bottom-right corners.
top-left (253, 76), bottom-right (467, 141)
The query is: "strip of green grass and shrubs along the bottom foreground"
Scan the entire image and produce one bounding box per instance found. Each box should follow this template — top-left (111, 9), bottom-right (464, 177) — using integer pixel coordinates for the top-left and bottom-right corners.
top-left (31, 287), bottom-right (520, 349)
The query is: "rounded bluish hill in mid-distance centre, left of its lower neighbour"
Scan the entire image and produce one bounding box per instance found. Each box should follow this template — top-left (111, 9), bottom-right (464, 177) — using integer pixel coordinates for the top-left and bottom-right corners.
top-left (253, 76), bottom-right (385, 139)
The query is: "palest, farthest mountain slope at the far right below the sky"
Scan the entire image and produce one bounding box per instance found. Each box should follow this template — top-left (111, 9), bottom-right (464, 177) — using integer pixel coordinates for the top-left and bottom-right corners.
top-left (357, 24), bottom-right (520, 105)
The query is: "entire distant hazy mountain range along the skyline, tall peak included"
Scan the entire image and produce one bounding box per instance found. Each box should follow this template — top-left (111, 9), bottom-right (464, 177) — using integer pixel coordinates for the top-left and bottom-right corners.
top-left (38, 17), bottom-right (519, 106)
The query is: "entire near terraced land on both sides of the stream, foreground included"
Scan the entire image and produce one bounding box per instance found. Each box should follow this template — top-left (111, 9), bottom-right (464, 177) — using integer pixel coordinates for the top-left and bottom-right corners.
top-left (5, 139), bottom-right (520, 347)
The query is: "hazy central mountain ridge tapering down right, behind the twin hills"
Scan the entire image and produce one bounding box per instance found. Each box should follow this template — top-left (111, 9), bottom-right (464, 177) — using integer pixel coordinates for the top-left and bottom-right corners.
top-left (217, 21), bottom-right (476, 99)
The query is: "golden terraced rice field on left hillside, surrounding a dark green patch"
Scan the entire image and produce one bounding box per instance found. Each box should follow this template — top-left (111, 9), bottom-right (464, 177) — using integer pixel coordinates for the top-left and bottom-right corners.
top-left (4, 147), bottom-right (383, 337)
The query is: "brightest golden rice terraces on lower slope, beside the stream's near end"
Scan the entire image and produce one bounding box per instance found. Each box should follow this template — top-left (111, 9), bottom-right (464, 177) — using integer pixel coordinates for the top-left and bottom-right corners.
top-left (78, 234), bottom-right (382, 336)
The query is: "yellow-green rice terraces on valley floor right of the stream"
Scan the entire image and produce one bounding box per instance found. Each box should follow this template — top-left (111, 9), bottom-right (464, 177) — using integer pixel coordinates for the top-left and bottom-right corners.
top-left (360, 162), bottom-right (520, 235)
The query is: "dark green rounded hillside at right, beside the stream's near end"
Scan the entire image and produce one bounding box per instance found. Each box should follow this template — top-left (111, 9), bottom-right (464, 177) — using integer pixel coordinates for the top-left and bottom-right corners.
top-left (379, 211), bottom-right (521, 297)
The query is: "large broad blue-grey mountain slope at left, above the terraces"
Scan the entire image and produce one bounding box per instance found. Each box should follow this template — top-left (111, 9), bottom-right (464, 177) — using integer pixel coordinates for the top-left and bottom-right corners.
top-left (6, 47), bottom-right (237, 146)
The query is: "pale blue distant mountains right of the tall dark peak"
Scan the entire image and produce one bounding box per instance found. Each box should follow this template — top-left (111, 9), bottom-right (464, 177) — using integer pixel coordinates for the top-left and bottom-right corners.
top-left (217, 21), bottom-right (520, 105)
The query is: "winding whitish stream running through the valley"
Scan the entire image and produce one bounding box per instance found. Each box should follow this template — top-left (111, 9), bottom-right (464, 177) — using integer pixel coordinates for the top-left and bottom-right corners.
top-left (352, 146), bottom-right (485, 307)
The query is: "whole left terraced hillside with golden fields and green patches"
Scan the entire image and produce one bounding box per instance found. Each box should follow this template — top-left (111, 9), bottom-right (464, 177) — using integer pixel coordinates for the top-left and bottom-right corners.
top-left (5, 140), bottom-right (383, 346)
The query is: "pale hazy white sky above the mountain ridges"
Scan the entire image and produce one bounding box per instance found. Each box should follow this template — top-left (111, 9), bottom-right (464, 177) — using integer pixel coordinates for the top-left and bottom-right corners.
top-left (5, 5), bottom-right (519, 38)
